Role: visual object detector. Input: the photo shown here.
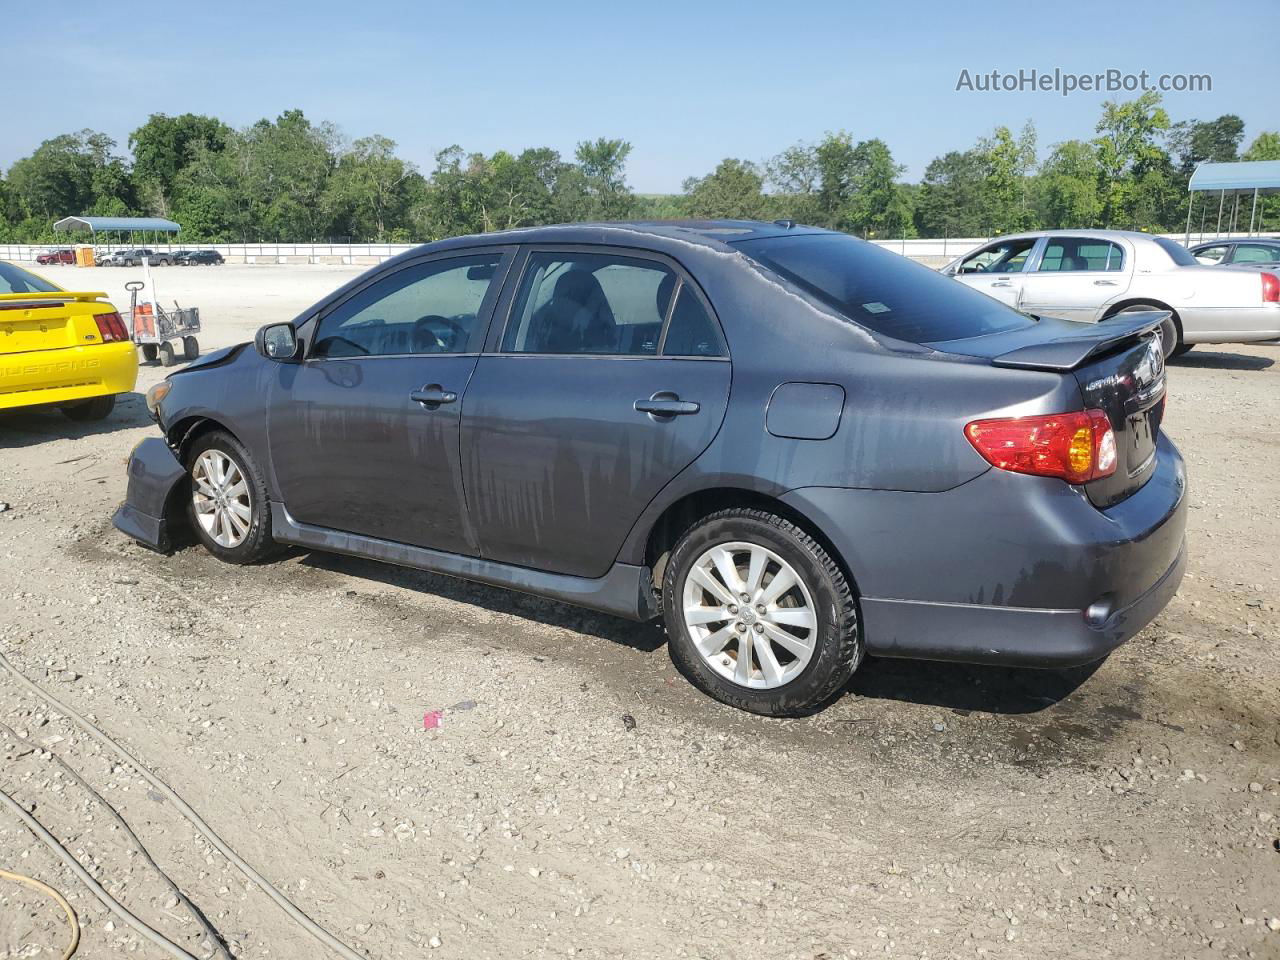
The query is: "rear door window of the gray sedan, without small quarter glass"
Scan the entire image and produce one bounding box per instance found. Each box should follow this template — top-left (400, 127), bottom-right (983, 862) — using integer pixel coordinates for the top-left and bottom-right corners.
top-left (502, 251), bottom-right (677, 356)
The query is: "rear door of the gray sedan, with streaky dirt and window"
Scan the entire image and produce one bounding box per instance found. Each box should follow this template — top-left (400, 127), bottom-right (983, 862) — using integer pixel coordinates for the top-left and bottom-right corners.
top-left (462, 247), bottom-right (731, 577)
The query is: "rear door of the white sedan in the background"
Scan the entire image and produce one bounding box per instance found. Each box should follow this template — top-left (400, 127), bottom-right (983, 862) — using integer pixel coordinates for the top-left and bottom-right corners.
top-left (1018, 236), bottom-right (1133, 321)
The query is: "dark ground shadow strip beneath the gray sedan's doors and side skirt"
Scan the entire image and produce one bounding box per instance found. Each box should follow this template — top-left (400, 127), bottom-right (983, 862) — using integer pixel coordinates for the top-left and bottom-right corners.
top-left (300, 550), bottom-right (667, 653)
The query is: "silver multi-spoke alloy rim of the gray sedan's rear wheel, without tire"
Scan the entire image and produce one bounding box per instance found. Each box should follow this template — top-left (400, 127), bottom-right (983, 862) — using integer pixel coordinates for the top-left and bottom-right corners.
top-left (681, 541), bottom-right (818, 690)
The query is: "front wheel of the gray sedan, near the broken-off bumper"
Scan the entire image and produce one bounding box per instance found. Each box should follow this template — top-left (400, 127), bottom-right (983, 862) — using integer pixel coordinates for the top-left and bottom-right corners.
top-left (187, 430), bottom-right (275, 563)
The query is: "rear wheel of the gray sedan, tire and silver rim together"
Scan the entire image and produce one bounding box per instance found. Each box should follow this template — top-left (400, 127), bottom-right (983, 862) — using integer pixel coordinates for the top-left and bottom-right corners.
top-left (662, 508), bottom-right (864, 717)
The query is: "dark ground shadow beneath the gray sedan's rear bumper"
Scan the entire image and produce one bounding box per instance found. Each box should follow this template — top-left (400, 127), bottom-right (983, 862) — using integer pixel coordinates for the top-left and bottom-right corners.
top-left (845, 657), bottom-right (1105, 714)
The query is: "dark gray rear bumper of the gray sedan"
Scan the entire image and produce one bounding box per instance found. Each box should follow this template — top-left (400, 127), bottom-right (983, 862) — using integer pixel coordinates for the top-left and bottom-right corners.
top-left (783, 435), bottom-right (1187, 667)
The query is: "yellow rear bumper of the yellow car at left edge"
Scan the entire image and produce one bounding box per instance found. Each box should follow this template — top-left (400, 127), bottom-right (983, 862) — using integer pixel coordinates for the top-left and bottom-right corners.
top-left (0, 343), bottom-right (138, 410)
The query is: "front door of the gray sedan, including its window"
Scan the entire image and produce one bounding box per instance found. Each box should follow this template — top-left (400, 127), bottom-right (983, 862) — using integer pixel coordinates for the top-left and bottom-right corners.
top-left (269, 247), bottom-right (512, 556)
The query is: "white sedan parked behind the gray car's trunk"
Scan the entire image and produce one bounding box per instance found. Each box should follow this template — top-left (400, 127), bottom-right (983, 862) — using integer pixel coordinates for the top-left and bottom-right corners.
top-left (942, 230), bottom-right (1280, 356)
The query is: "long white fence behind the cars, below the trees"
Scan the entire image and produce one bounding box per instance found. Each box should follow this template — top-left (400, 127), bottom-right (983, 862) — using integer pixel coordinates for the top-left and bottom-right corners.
top-left (0, 233), bottom-right (1244, 266)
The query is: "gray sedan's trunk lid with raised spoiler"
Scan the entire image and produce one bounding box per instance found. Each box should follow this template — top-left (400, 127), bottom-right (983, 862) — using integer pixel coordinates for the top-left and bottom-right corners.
top-left (929, 311), bottom-right (1169, 509)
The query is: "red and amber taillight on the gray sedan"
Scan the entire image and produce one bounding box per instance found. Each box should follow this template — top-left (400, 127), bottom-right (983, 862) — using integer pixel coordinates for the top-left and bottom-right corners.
top-left (964, 410), bottom-right (1116, 484)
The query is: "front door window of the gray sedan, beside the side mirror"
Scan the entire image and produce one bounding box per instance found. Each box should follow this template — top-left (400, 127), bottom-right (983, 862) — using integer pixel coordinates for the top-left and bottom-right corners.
top-left (311, 252), bottom-right (502, 358)
